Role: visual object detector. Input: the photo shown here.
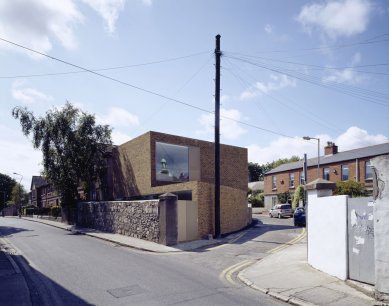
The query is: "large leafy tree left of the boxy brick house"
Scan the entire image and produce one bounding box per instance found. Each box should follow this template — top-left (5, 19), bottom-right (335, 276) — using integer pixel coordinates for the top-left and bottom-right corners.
top-left (12, 102), bottom-right (112, 215)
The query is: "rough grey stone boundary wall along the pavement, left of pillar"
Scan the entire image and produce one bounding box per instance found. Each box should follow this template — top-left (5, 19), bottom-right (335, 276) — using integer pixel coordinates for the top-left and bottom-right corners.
top-left (77, 200), bottom-right (160, 243)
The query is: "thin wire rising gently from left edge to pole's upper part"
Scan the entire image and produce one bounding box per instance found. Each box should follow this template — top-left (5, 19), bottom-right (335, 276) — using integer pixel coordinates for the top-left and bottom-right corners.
top-left (0, 51), bottom-right (211, 79)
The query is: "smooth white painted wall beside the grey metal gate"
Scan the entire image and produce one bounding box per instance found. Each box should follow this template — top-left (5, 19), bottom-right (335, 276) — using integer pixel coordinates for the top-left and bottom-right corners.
top-left (307, 193), bottom-right (347, 280)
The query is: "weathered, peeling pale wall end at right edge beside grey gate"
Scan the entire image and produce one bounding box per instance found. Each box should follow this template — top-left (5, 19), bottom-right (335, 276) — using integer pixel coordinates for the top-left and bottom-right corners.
top-left (371, 155), bottom-right (389, 299)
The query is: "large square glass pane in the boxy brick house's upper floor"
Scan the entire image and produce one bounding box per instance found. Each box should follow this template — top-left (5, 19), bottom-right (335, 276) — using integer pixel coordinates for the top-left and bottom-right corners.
top-left (155, 142), bottom-right (189, 182)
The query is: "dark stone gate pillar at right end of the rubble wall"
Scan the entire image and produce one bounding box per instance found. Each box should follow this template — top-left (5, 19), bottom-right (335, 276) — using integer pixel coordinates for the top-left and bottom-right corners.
top-left (158, 193), bottom-right (178, 245)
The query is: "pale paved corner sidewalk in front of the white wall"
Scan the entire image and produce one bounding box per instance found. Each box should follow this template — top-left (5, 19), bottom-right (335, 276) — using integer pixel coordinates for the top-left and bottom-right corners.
top-left (238, 237), bottom-right (385, 306)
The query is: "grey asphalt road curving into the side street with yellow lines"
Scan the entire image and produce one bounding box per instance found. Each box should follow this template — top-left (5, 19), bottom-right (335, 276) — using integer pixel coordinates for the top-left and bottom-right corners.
top-left (0, 216), bottom-right (301, 305)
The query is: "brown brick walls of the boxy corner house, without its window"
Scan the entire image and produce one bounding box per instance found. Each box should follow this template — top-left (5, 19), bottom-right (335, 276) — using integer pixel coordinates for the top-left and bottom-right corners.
top-left (108, 132), bottom-right (246, 238)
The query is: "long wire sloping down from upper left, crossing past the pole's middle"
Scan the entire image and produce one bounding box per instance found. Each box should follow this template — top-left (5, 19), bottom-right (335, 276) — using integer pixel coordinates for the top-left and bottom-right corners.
top-left (0, 37), bottom-right (295, 139)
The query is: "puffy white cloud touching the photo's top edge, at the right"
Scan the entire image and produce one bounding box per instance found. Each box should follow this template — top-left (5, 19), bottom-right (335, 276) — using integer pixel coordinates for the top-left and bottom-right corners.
top-left (297, 0), bottom-right (372, 39)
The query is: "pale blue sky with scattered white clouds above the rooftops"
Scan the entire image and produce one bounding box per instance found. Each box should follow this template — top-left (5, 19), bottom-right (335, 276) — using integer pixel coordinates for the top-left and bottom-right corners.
top-left (0, 0), bottom-right (389, 189)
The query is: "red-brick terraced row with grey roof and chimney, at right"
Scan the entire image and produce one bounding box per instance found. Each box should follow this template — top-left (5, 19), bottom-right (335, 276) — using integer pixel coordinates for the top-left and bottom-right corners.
top-left (264, 142), bottom-right (389, 209)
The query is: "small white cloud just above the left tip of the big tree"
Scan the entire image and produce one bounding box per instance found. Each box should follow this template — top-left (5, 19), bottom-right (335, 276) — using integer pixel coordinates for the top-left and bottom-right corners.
top-left (11, 80), bottom-right (53, 105)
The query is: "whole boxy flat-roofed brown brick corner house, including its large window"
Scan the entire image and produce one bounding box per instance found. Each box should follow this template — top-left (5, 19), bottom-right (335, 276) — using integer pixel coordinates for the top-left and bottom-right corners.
top-left (101, 131), bottom-right (251, 238)
